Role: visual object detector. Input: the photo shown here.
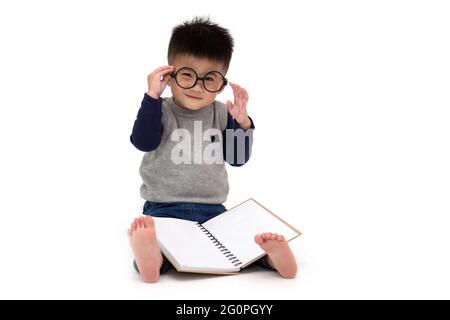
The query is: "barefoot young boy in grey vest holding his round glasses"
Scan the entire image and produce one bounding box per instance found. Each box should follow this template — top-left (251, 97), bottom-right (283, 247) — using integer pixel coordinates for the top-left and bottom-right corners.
top-left (128, 18), bottom-right (297, 282)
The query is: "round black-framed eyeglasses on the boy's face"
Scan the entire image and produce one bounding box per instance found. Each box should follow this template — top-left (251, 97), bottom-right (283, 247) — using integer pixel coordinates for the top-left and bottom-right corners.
top-left (171, 67), bottom-right (228, 93)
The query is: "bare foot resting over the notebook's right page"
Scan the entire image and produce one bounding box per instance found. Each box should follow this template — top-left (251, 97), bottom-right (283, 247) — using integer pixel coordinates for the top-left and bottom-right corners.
top-left (255, 232), bottom-right (297, 279)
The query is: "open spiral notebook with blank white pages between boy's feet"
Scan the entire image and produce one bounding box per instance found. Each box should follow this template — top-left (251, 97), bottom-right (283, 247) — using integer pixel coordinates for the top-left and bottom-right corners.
top-left (153, 199), bottom-right (301, 273)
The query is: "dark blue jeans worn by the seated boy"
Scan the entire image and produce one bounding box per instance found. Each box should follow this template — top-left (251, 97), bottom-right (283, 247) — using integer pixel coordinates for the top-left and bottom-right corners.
top-left (133, 201), bottom-right (274, 274)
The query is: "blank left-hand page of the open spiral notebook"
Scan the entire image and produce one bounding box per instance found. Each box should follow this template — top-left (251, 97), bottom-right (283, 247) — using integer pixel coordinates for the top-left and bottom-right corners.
top-left (153, 217), bottom-right (239, 272)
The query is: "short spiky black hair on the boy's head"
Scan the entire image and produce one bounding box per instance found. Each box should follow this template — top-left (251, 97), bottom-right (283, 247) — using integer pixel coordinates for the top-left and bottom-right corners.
top-left (167, 17), bottom-right (234, 69)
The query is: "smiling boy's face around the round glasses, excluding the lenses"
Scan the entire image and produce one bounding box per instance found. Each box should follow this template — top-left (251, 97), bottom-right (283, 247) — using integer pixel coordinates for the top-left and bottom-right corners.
top-left (170, 54), bottom-right (226, 110)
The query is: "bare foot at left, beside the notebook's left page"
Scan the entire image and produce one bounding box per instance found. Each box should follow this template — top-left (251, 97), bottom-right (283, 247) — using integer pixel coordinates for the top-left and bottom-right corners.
top-left (128, 216), bottom-right (163, 282)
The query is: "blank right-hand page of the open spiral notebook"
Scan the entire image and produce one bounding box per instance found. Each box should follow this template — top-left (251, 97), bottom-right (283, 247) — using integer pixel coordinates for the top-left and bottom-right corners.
top-left (203, 199), bottom-right (299, 265)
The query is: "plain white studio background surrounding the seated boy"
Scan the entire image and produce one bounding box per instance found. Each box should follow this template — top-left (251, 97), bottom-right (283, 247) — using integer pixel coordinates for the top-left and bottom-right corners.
top-left (0, 0), bottom-right (450, 299)
